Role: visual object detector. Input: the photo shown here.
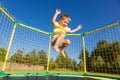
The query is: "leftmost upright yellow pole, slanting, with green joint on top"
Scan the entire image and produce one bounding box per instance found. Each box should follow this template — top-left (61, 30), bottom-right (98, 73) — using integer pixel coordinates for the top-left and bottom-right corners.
top-left (2, 23), bottom-right (18, 71)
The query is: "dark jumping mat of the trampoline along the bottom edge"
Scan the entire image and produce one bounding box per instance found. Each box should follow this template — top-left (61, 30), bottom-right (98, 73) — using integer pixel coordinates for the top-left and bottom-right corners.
top-left (1, 76), bottom-right (97, 80)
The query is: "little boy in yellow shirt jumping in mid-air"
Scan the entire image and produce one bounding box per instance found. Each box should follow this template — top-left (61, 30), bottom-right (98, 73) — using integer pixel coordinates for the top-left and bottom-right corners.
top-left (51, 9), bottom-right (82, 57)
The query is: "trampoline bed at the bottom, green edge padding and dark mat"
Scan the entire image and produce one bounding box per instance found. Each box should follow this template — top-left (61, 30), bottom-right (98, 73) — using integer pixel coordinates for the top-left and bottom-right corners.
top-left (0, 73), bottom-right (119, 80)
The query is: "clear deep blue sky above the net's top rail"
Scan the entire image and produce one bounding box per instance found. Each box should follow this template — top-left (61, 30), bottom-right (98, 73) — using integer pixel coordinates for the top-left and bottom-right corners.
top-left (0, 0), bottom-right (120, 34)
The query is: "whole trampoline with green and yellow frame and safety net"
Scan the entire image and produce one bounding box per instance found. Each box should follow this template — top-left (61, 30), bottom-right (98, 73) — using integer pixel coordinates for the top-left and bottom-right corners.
top-left (0, 1), bottom-right (120, 80)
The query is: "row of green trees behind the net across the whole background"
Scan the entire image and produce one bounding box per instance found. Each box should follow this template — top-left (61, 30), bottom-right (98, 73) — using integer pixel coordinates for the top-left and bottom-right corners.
top-left (0, 40), bottom-right (120, 74)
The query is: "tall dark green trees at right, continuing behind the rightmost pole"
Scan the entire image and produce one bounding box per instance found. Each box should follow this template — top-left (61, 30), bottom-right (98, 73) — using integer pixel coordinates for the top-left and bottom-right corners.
top-left (79, 40), bottom-right (120, 74)
